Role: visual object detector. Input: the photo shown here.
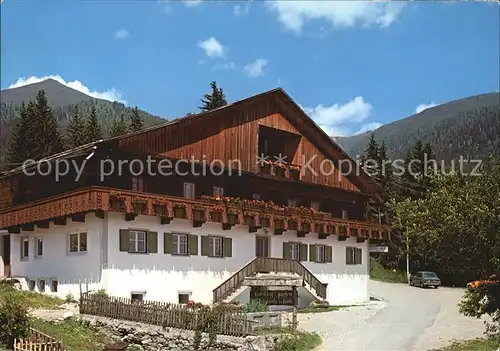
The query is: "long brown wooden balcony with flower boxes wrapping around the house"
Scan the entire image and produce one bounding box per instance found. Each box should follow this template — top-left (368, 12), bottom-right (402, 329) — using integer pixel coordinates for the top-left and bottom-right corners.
top-left (0, 187), bottom-right (389, 240)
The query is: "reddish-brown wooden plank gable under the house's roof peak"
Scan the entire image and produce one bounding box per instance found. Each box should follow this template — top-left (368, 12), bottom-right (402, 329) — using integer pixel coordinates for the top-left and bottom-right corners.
top-left (118, 89), bottom-right (376, 192)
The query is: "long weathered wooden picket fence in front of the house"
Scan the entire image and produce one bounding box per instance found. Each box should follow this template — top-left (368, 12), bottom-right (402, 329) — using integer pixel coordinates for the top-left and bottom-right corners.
top-left (80, 293), bottom-right (252, 336)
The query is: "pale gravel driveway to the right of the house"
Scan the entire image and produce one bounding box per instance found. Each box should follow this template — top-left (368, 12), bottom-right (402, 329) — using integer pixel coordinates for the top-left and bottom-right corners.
top-left (299, 281), bottom-right (485, 351)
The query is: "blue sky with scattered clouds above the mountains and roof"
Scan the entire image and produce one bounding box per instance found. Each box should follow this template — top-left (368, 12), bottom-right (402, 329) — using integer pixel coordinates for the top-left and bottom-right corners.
top-left (0, 0), bottom-right (500, 135)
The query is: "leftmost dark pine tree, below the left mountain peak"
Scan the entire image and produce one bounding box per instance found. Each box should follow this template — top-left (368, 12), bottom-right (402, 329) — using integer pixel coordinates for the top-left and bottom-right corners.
top-left (6, 101), bottom-right (36, 169)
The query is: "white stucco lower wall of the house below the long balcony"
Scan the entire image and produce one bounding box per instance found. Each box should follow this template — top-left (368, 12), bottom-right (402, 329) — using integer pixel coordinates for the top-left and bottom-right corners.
top-left (6, 213), bottom-right (369, 305)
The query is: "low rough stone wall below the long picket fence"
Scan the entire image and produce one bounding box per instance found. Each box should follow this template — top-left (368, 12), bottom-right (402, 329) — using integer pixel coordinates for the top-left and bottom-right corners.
top-left (80, 315), bottom-right (276, 351)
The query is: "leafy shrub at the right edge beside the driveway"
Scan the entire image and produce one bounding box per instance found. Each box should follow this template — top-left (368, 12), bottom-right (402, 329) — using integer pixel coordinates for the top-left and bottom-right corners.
top-left (459, 276), bottom-right (500, 339)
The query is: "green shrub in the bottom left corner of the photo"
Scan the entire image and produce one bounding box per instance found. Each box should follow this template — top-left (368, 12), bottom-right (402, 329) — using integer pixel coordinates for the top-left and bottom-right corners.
top-left (0, 293), bottom-right (30, 348)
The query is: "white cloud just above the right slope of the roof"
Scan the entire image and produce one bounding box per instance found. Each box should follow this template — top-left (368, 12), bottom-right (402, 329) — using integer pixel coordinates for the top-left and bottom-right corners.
top-left (302, 96), bottom-right (381, 136)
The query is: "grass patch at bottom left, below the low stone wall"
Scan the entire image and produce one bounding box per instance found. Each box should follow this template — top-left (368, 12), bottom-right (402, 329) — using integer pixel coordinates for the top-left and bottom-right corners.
top-left (31, 318), bottom-right (110, 351)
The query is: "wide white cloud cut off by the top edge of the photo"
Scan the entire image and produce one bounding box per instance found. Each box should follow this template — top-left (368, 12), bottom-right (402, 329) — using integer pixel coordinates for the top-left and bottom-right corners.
top-left (267, 1), bottom-right (405, 33)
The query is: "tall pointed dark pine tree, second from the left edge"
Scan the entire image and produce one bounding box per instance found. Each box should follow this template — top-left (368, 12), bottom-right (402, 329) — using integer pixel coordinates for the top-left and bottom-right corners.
top-left (32, 90), bottom-right (64, 158)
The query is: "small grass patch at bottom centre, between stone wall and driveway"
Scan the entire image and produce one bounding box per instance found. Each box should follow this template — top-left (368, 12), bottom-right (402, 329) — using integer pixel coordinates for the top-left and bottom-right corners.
top-left (256, 328), bottom-right (322, 351)
